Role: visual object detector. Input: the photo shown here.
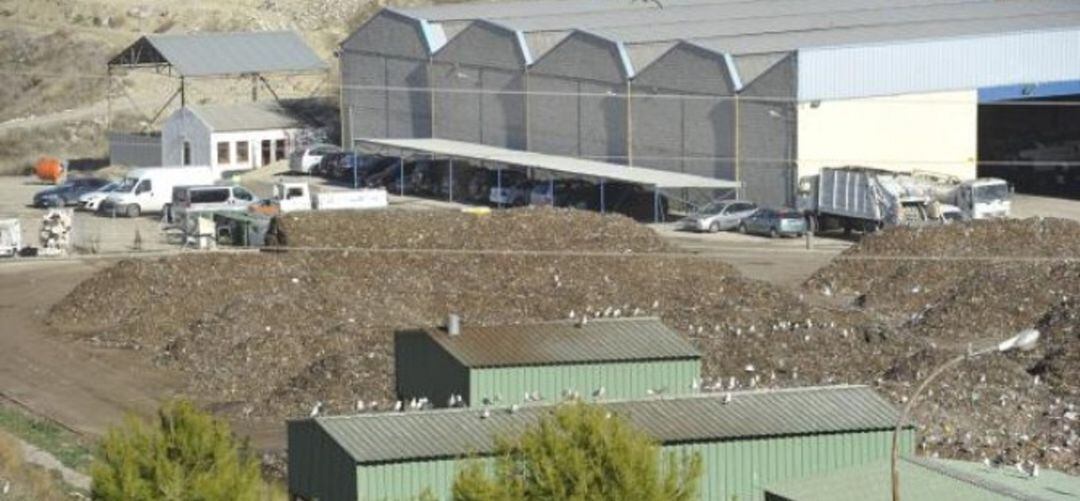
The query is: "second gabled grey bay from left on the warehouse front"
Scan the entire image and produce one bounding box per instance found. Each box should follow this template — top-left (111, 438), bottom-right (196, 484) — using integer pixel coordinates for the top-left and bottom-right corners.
top-left (431, 21), bottom-right (527, 150)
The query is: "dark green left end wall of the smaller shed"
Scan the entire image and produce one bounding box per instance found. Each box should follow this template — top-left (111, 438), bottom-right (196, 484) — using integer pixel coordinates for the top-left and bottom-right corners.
top-left (394, 331), bottom-right (469, 407)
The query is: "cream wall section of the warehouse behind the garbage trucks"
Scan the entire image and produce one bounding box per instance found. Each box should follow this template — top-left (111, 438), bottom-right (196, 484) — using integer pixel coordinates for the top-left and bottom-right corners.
top-left (798, 91), bottom-right (978, 179)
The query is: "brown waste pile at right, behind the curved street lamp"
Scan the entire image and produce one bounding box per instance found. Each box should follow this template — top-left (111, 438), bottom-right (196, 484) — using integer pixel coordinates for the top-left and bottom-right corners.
top-left (806, 215), bottom-right (1080, 473)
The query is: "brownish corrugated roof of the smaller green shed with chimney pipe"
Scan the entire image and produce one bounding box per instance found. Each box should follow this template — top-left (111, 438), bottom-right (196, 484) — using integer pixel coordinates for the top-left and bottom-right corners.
top-left (412, 317), bottom-right (701, 368)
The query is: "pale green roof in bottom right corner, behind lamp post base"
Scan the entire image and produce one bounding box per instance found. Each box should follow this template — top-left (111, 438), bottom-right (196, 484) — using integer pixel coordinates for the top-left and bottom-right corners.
top-left (766, 458), bottom-right (1080, 501)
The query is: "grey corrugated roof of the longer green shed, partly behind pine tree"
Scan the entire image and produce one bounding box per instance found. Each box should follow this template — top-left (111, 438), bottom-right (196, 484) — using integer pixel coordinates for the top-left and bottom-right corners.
top-left (298, 385), bottom-right (899, 464)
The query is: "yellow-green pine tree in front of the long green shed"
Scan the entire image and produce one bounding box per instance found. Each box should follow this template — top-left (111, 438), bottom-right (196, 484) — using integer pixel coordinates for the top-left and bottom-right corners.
top-left (454, 403), bottom-right (702, 501)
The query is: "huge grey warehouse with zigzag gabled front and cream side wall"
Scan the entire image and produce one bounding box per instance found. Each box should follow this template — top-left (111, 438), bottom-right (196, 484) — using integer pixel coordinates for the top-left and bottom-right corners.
top-left (340, 0), bottom-right (1080, 205)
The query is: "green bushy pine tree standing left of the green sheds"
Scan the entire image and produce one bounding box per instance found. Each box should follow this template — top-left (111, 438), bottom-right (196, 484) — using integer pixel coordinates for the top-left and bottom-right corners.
top-left (91, 401), bottom-right (268, 501)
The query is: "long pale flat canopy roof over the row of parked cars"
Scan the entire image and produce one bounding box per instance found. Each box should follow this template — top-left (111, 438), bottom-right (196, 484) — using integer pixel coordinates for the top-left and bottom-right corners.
top-left (356, 138), bottom-right (740, 189)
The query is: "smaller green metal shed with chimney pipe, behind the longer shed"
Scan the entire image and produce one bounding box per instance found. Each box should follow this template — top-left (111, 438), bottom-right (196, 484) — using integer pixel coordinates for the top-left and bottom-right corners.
top-left (394, 317), bottom-right (701, 406)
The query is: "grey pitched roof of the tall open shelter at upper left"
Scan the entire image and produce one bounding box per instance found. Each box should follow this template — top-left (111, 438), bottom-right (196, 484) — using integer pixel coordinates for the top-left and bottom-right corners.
top-left (109, 31), bottom-right (327, 77)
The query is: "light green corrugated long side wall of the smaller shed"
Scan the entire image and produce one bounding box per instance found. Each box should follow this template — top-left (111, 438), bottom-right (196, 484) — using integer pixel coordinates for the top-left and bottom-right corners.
top-left (469, 361), bottom-right (701, 405)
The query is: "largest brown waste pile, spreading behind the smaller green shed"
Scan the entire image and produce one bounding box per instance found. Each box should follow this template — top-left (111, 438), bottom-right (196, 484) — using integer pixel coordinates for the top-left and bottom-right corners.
top-left (53, 209), bottom-right (872, 420)
